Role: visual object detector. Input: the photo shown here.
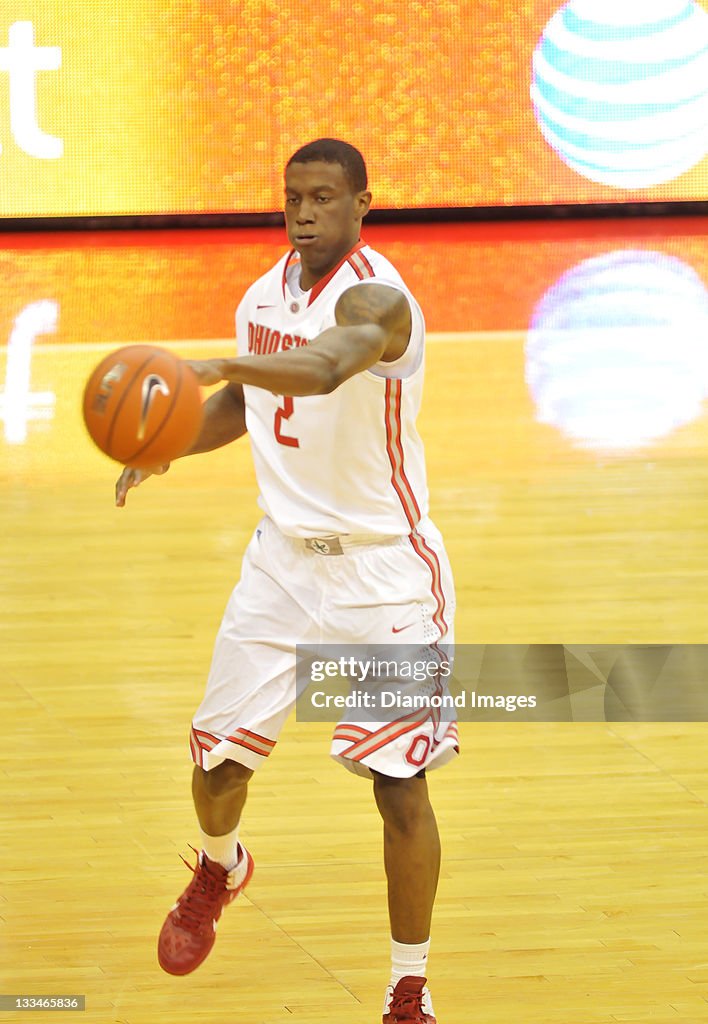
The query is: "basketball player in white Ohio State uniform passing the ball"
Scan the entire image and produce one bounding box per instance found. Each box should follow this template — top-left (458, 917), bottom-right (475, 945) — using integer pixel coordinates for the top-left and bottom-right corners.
top-left (116, 139), bottom-right (457, 1024)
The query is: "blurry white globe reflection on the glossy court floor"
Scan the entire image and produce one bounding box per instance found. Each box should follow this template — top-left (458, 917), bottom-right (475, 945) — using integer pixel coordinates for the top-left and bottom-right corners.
top-left (526, 250), bottom-right (708, 452)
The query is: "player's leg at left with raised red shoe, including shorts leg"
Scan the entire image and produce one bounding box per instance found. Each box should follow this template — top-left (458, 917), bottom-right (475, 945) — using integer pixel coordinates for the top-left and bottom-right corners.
top-left (158, 523), bottom-right (309, 975)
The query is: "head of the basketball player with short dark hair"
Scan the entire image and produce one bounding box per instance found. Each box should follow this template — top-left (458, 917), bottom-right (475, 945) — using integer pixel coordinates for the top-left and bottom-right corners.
top-left (285, 138), bottom-right (371, 288)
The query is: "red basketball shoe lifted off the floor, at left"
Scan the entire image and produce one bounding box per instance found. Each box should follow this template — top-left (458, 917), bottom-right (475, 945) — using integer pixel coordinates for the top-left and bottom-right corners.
top-left (158, 845), bottom-right (253, 974)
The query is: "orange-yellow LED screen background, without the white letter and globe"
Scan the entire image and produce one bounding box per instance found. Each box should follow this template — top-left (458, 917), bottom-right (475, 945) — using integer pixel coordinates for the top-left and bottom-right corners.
top-left (0, 0), bottom-right (708, 217)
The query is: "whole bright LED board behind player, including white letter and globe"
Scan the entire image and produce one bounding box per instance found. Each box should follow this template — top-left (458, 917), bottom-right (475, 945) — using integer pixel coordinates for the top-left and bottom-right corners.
top-left (0, 0), bottom-right (708, 217)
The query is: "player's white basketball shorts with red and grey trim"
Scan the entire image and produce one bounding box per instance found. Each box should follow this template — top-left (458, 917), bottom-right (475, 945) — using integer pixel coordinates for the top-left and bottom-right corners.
top-left (190, 517), bottom-right (458, 778)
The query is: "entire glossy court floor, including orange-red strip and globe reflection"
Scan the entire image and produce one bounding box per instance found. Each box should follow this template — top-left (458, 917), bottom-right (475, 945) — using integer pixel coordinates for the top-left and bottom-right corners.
top-left (0, 218), bottom-right (708, 1024)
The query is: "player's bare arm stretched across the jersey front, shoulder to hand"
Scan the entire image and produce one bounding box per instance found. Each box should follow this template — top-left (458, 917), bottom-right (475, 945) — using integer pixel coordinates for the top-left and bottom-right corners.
top-left (190, 284), bottom-right (412, 397)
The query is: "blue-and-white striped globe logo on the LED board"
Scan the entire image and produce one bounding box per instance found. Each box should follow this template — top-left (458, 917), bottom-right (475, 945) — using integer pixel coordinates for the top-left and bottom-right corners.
top-left (531, 0), bottom-right (708, 188)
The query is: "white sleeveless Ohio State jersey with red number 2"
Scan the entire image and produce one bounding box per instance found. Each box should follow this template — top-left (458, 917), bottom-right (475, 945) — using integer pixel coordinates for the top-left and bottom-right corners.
top-left (236, 242), bottom-right (428, 538)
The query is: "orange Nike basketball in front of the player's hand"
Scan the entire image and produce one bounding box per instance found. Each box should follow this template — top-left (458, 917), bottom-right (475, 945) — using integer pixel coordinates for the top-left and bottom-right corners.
top-left (83, 345), bottom-right (202, 469)
